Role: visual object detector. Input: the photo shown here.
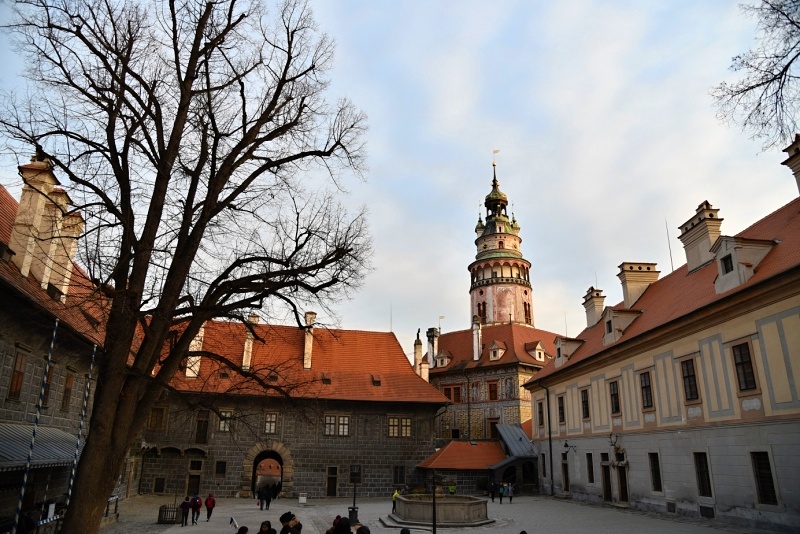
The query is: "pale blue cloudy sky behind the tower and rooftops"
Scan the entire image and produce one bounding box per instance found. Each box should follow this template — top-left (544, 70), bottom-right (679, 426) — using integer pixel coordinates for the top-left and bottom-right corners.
top-left (0, 0), bottom-right (798, 360)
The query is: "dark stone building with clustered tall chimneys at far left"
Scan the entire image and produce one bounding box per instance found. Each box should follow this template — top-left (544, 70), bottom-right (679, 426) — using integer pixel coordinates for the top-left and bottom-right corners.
top-left (0, 158), bottom-right (103, 531)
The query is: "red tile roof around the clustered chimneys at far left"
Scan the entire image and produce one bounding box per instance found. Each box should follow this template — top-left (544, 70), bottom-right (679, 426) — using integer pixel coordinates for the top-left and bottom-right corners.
top-left (0, 185), bottom-right (106, 345)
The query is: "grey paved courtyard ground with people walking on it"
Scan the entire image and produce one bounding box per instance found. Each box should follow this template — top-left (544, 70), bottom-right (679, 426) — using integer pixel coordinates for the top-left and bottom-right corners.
top-left (101, 495), bottom-right (770, 534)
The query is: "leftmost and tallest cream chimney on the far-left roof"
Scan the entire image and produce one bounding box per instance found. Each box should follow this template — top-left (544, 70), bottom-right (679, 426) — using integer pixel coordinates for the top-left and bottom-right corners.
top-left (8, 157), bottom-right (59, 281)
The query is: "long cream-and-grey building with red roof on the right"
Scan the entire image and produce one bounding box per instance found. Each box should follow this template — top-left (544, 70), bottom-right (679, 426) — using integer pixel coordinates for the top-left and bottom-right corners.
top-left (525, 136), bottom-right (800, 531)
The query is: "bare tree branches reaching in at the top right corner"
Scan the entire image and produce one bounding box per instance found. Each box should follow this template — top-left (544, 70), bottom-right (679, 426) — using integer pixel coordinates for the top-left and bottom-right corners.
top-left (711, 0), bottom-right (800, 150)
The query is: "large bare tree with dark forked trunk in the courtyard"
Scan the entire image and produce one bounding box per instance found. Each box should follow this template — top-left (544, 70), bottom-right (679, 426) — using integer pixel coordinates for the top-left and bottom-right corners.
top-left (0, 0), bottom-right (370, 533)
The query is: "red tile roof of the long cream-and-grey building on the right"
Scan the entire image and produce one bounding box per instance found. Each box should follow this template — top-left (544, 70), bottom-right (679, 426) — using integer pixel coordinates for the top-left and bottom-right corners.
top-left (532, 198), bottom-right (800, 381)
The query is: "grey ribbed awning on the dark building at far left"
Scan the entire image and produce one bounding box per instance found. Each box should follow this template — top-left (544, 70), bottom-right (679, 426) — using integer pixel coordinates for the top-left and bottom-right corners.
top-left (0, 423), bottom-right (82, 472)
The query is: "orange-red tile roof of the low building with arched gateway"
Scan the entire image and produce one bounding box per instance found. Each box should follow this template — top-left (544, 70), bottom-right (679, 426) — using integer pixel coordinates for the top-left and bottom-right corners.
top-left (173, 321), bottom-right (447, 404)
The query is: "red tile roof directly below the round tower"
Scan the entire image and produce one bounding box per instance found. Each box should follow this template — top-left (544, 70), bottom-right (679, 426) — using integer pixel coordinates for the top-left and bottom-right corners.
top-left (430, 323), bottom-right (557, 375)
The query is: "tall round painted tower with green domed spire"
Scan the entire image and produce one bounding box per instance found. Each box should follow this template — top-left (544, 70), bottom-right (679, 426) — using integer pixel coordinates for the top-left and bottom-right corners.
top-left (469, 163), bottom-right (533, 325)
